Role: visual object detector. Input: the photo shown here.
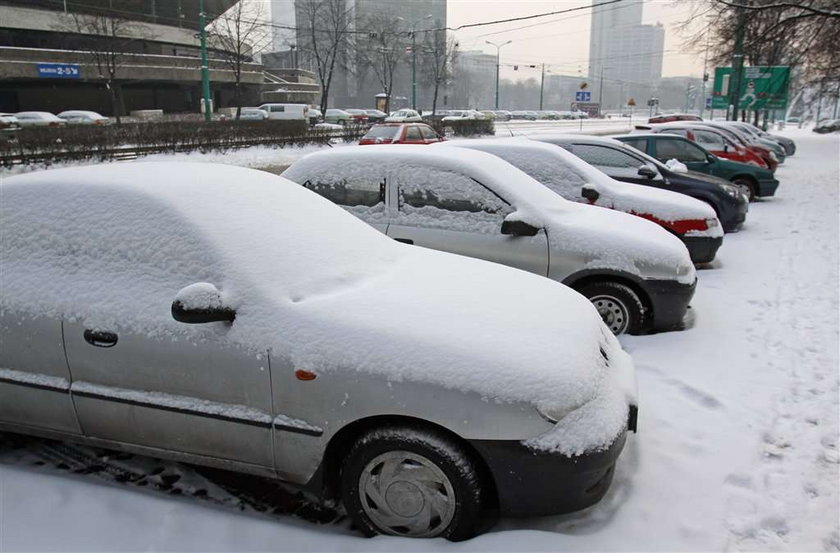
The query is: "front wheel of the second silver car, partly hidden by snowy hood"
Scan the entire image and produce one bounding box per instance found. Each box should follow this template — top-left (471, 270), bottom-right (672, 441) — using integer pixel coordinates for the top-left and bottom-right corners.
top-left (578, 281), bottom-right (645, 335)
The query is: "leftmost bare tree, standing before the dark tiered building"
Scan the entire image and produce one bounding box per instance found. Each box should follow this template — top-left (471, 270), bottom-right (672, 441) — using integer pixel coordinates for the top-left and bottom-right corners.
top-left (60, 2), bottom-right (153, 124)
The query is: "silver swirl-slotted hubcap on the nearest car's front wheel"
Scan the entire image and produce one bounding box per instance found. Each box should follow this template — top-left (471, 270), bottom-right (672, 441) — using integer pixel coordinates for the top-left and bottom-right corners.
top-left (359, 451), bottom-right (455, 538)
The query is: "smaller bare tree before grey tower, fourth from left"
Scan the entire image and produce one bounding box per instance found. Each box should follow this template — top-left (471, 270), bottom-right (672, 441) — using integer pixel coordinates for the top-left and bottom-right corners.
top-left (358, 14), bottom-right (410, 104)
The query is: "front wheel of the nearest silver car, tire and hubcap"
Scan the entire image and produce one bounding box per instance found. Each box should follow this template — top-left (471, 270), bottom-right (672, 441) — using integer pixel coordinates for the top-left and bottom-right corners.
top-left (341, 426), bottom-right (487, 541)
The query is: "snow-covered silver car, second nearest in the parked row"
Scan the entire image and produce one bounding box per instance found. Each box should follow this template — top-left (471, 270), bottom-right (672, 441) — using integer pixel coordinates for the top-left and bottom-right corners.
top-left (283, 145), bottom-right (697, 334)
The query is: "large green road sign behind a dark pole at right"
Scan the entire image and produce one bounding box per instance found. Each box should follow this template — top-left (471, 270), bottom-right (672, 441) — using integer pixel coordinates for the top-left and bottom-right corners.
top-left (712, 66), bottom-right (790, 110)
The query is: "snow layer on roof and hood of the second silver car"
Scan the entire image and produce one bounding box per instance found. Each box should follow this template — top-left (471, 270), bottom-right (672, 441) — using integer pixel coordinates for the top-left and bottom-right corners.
top-left (283, 145), bottom-right (695, 283)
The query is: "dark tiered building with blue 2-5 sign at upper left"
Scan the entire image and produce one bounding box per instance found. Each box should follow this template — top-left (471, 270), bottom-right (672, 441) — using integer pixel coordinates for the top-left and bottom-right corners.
top-left (0, 0), bottom-right (264, 115)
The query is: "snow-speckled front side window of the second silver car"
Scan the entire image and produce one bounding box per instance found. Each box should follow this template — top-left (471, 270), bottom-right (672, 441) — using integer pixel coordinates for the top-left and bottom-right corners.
top-left (395, 165), bottom-right (513, 234)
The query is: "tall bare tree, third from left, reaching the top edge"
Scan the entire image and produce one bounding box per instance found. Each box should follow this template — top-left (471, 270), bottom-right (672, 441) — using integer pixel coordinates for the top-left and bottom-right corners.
top-left (295, 0), bottom-right (353, 113)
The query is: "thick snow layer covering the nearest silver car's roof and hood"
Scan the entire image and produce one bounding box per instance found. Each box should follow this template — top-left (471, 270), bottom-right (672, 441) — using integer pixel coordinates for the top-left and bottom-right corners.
top-left (0, 162), bottom-right (634, 454)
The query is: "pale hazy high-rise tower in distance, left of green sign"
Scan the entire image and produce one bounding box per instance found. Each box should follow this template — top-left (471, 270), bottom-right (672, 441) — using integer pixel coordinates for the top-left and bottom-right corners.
top-left (589, 2), bottom-right (665, 110)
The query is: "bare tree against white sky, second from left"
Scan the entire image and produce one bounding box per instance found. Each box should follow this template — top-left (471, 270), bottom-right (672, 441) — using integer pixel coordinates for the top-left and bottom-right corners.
top-left (209, 0), bottom-right (271, 119)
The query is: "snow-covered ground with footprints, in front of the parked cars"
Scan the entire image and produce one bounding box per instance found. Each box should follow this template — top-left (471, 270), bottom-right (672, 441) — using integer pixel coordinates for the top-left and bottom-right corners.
top-left (0, 129), bottom-right (840, 551)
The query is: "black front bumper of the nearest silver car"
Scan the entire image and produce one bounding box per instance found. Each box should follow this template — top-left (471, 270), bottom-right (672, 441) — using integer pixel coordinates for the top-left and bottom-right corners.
top-left (470, 422), bottom-right (636, 516)
